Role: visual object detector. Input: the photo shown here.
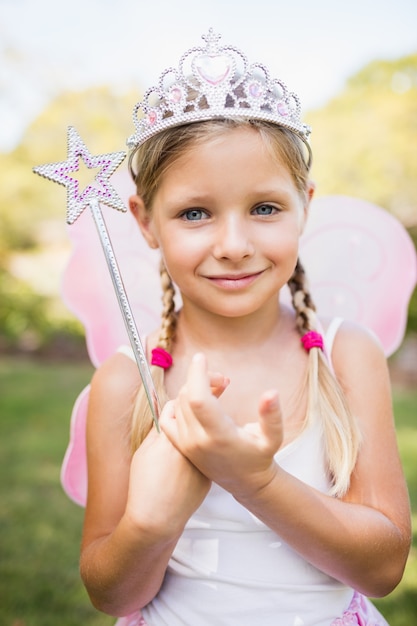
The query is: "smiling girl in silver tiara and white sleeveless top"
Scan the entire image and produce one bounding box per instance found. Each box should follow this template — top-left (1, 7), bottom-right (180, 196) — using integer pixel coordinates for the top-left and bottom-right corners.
top-left (81, 32), bottom-right (410, 626)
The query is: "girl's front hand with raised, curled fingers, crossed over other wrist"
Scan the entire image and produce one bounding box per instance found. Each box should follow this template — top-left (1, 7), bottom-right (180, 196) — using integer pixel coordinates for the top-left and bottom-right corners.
top-left (160, 354), bottom-right (283, 497)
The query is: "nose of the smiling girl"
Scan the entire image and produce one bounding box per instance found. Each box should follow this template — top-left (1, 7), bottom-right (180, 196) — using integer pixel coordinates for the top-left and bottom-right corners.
top-left (214, 212), bottom-right (255, 262)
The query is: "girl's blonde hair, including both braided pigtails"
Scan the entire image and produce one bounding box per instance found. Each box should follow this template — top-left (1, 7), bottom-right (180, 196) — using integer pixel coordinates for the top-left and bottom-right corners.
top-left (131, 119), bottom-right (360, 496)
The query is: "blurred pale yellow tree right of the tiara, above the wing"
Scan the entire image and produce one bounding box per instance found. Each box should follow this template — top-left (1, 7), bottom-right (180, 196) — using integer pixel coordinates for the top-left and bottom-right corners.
top-left (307, 54), bottom-right (417, 225)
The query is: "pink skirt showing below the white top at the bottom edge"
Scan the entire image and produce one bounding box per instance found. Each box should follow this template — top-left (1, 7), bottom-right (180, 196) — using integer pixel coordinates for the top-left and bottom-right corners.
top-left (115, 591), bottom-right (389, 626)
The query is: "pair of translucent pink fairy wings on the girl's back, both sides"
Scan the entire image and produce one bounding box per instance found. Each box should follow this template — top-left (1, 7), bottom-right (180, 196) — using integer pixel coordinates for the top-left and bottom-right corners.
top-left (61, 184), bottom-right (417, 505)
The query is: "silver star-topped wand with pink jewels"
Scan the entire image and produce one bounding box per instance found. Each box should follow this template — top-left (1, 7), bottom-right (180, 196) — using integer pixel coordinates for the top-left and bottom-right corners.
top-left (33, 126), bottom-right (160, 432)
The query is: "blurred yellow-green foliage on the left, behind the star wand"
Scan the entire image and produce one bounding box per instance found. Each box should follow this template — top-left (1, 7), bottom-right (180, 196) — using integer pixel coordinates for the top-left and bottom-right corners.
top-left (0, 87), bottom-right (139, 352)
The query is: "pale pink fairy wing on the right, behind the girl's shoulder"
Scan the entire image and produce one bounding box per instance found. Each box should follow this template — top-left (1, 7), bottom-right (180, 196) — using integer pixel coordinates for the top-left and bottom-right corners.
top-left (300, 196), bottom-right (417, 356)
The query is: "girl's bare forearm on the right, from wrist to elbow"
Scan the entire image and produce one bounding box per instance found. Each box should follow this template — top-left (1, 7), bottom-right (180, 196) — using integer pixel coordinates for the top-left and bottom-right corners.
top-left (235, 467), bottom-right (410, 597)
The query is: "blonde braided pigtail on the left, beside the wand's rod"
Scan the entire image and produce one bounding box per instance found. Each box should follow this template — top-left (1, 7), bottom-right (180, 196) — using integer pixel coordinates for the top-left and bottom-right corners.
top-left (130, 261), bottom-right (177, 453)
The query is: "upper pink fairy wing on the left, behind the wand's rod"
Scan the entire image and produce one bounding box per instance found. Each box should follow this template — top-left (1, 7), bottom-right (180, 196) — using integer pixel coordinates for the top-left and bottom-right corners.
top-left (62, 172), bottom-right (161, 367)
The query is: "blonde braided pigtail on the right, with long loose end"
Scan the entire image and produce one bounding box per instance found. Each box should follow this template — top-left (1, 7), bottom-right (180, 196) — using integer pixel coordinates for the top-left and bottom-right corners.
top-left (288, 260), bottom-right (360, 496)
